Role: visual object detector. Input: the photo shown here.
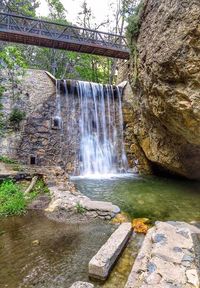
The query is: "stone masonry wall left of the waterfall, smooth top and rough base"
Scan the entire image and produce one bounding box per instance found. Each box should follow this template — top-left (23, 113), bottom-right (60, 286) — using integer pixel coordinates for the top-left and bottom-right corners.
top-left (0, 70), bottom-right (76, 172)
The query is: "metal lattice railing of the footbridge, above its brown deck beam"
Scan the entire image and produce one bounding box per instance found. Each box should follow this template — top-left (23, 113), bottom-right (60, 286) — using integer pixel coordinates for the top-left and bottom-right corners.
top-left (0, 13), bottom-right (128, 51)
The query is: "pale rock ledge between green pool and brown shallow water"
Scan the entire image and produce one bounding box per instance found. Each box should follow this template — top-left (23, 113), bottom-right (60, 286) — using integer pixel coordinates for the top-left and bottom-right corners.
top-left (32, 166), bottom-right (120, 222)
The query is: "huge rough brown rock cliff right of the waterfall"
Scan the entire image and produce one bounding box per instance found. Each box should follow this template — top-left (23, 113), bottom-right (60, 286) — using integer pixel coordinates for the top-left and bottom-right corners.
top-left (124, 0), bottom-right (200, 179)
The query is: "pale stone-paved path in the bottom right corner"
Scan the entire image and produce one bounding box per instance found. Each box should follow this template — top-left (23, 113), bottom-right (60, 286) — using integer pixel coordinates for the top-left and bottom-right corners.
top-left (125, 221), bottom-right (200, 288)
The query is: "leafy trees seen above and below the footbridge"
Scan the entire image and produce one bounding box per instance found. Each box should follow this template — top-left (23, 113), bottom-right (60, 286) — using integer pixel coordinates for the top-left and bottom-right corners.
top-left (0, 0), bottom-right (113, 83)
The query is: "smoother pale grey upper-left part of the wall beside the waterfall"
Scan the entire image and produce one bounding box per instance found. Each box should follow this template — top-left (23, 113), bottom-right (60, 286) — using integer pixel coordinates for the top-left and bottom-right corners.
top-left (0, 69), bottom-right (55, 158)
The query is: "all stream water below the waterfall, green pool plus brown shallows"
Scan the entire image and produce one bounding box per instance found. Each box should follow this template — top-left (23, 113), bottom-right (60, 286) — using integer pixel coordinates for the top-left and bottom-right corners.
top-left (0, 176), bottom-right (200, 288)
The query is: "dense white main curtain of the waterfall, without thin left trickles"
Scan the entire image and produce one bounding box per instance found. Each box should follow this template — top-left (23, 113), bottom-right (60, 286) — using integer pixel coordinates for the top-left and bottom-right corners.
top-left (77, 81), bottom-right (128, 176)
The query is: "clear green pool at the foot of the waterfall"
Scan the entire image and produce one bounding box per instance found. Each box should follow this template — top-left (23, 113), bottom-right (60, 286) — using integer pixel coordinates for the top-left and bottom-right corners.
top-left (73, 174), bottom-right (200, 222)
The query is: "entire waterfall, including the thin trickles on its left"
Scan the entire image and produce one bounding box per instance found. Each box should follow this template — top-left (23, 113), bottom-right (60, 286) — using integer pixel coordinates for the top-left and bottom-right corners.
top-left (57, 80), bottom-right (128, 176)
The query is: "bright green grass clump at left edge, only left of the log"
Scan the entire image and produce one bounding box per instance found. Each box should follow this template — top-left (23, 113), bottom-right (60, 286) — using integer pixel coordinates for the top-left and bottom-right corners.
top-left (0, 180), bottom-right (26, 217)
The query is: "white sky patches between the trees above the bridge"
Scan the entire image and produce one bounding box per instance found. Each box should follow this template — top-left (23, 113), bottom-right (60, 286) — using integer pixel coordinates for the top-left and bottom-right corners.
top-left (37, 0), bottom-right (114, 28)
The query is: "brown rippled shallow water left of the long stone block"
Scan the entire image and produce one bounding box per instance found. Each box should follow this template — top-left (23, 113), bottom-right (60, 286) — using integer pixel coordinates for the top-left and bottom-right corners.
top-left (0, 213), bottom-right (119, 288)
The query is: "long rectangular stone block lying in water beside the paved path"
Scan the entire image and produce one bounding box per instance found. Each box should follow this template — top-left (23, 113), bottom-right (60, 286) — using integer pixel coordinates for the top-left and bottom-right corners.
top-left (89, 223), bottom-right (132, 280)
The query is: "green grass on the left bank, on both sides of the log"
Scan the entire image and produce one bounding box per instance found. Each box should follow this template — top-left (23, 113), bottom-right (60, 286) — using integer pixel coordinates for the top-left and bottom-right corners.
top-left (0, 179), bottom-right (49, 217)
